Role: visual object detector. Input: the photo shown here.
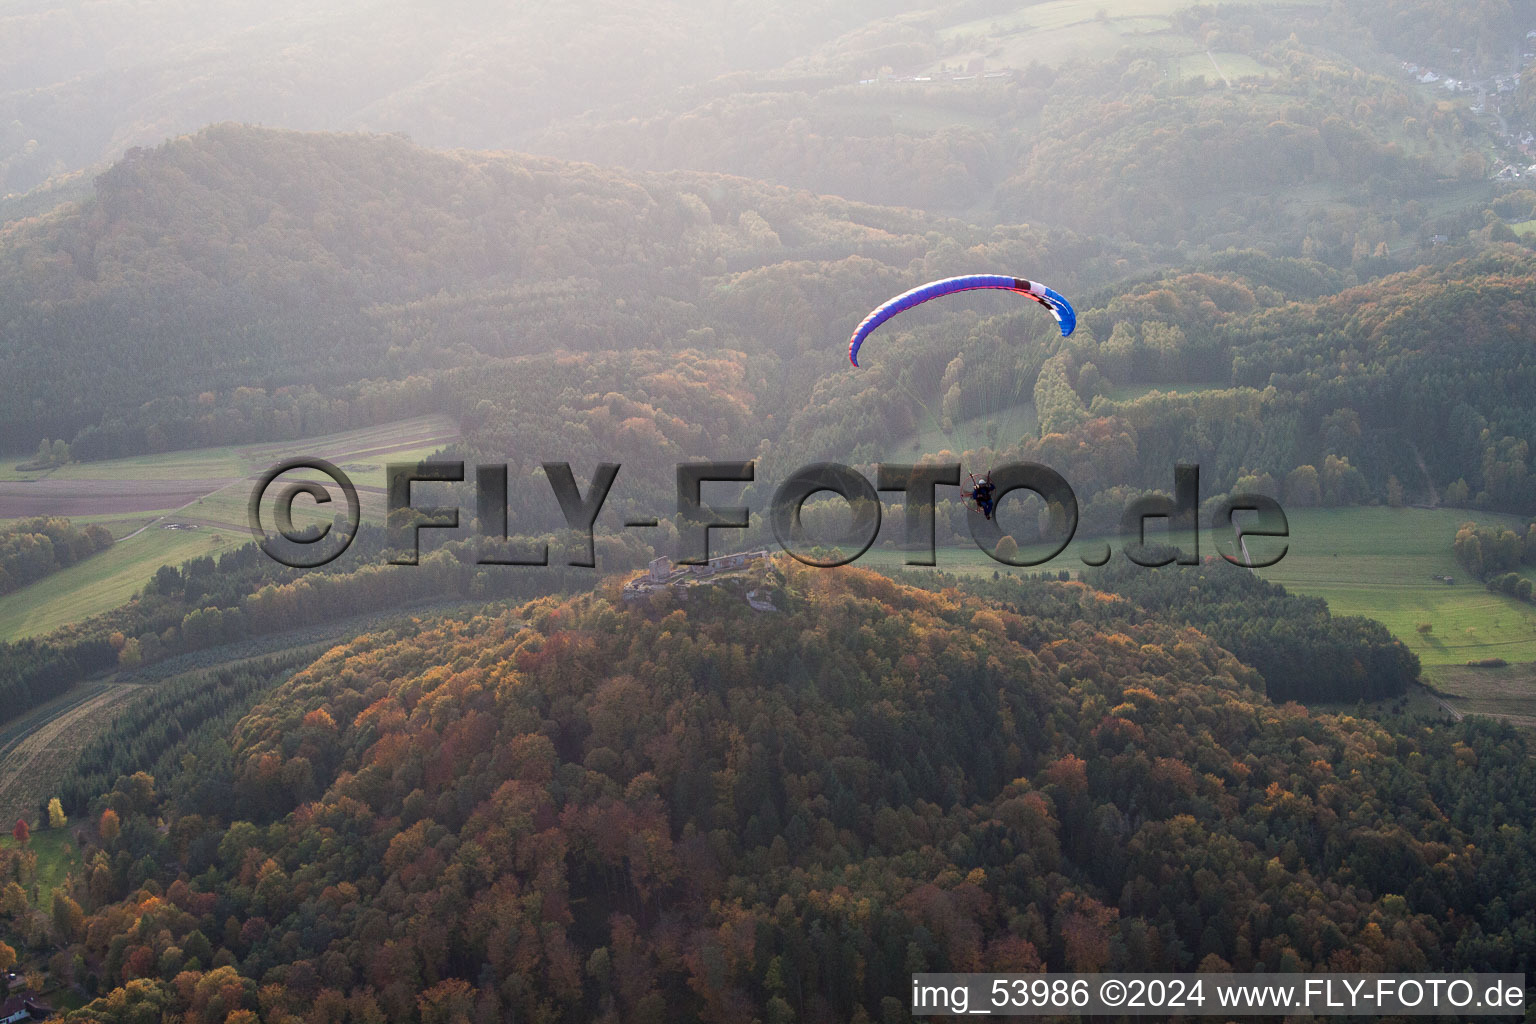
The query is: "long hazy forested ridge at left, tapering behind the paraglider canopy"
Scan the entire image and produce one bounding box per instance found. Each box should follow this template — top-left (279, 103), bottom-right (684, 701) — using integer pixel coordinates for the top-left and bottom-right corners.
top-left (0, 124), bottom-right (1124, 448)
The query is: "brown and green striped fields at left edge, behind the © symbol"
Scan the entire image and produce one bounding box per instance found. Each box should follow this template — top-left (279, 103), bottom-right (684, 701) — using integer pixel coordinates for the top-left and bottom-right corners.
top-left (0, 416), bottom-right (459, 640)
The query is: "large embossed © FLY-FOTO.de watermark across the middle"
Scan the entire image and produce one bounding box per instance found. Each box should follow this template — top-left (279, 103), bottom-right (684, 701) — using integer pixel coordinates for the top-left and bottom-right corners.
top-left (247, 459), bottom-right (1290, 568)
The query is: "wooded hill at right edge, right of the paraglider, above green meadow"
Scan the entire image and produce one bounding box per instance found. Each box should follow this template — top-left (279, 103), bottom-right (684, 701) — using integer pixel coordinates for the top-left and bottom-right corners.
top-left (995, 245), bottom-right (1536, 514)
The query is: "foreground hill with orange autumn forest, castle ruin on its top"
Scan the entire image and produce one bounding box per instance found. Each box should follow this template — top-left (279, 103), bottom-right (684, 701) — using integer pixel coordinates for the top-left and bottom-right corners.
top-left (54, 567), bottom-right (1536, 1022)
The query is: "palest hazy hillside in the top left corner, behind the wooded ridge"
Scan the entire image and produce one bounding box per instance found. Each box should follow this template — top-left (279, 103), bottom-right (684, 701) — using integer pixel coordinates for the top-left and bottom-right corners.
top-left (0, 0), bottom-right (908, 195)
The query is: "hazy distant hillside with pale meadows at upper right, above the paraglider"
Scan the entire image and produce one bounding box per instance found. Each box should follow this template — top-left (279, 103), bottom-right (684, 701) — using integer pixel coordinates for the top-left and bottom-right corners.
top-left (528, 0), bottom-right (1511, 245)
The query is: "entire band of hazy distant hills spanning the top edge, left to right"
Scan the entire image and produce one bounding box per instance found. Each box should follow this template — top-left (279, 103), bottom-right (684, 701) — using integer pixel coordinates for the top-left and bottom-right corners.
top-left (0, 0), bottom-right (1536, 244)
